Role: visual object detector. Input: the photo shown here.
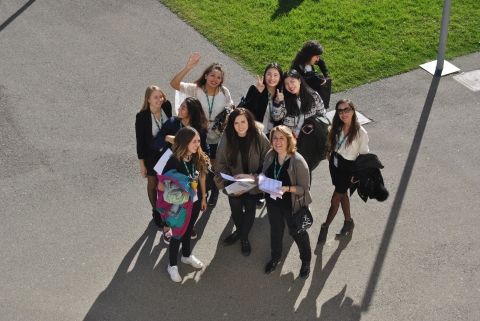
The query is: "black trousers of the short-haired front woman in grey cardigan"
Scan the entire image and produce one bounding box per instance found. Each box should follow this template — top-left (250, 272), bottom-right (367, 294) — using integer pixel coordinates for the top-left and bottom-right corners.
top-left (267, 201), bottom-right (312, 262)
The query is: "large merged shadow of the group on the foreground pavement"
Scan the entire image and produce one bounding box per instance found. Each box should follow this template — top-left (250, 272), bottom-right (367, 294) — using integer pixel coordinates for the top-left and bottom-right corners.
top-left (84, 206), bottom-right (314, 320)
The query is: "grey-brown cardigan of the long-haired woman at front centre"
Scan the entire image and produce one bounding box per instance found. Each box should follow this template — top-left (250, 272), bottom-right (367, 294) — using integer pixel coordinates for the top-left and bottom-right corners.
top-left (215, 129), bottom-right (270, 196)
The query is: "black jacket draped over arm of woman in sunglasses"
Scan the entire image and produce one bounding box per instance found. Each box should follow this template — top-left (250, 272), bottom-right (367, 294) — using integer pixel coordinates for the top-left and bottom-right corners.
top-left (350, 154), bottom-right (389, 202)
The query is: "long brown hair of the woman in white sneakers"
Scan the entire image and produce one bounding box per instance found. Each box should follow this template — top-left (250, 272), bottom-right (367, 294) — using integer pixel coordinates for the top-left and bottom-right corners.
top-left (172, 126), bottom-right (208, 174)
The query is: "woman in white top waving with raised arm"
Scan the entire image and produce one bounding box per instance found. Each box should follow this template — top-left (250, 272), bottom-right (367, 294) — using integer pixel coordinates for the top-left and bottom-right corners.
top-left (170, 52), bottom-right (233, 206)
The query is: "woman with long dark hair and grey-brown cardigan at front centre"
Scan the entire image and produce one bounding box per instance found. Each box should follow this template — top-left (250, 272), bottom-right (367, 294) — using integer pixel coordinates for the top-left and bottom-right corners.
top-left (215, 108), bottom-right (270, 256)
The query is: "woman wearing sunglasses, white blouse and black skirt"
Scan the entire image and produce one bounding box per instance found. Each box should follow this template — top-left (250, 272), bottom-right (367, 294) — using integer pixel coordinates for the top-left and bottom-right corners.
top-left (318, 99), bottom-right (369, 243)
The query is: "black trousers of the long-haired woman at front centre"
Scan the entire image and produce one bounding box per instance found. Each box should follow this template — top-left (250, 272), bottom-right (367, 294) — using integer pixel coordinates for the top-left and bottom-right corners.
top-left (228, 193), bottom-right (259, 241)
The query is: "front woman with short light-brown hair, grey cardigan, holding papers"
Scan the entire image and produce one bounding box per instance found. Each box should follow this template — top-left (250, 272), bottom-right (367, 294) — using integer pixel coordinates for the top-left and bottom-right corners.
top-left (263, 125), bottom-right (312, 278)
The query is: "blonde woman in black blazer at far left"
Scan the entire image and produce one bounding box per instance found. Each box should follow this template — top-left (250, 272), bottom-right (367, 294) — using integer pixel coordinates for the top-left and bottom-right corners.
top-left (135, 86), bottom-right (172, 228)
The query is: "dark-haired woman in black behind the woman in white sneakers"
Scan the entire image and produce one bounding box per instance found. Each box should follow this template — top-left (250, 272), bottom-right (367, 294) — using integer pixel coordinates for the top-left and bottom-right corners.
top-left (153, 97), bottom-right (210, 241)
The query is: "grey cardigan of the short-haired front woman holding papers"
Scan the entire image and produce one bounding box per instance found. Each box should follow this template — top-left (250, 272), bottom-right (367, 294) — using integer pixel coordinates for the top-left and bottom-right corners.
top-left (263, 150), bottom-right (312, 213)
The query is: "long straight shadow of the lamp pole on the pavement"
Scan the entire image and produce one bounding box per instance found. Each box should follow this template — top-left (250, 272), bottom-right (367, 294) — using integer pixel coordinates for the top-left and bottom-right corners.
top-left (361, 77), bottom-right (440, 311)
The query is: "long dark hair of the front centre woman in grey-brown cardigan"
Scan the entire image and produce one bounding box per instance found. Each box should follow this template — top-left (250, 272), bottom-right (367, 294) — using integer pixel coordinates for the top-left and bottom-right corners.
top-left (224, 108), bottom-right (260, 167)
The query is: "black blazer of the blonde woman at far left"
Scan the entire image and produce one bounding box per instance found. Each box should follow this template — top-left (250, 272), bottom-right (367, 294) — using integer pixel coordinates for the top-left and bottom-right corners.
top-left (135, 100), bottom-right (172, 159)
